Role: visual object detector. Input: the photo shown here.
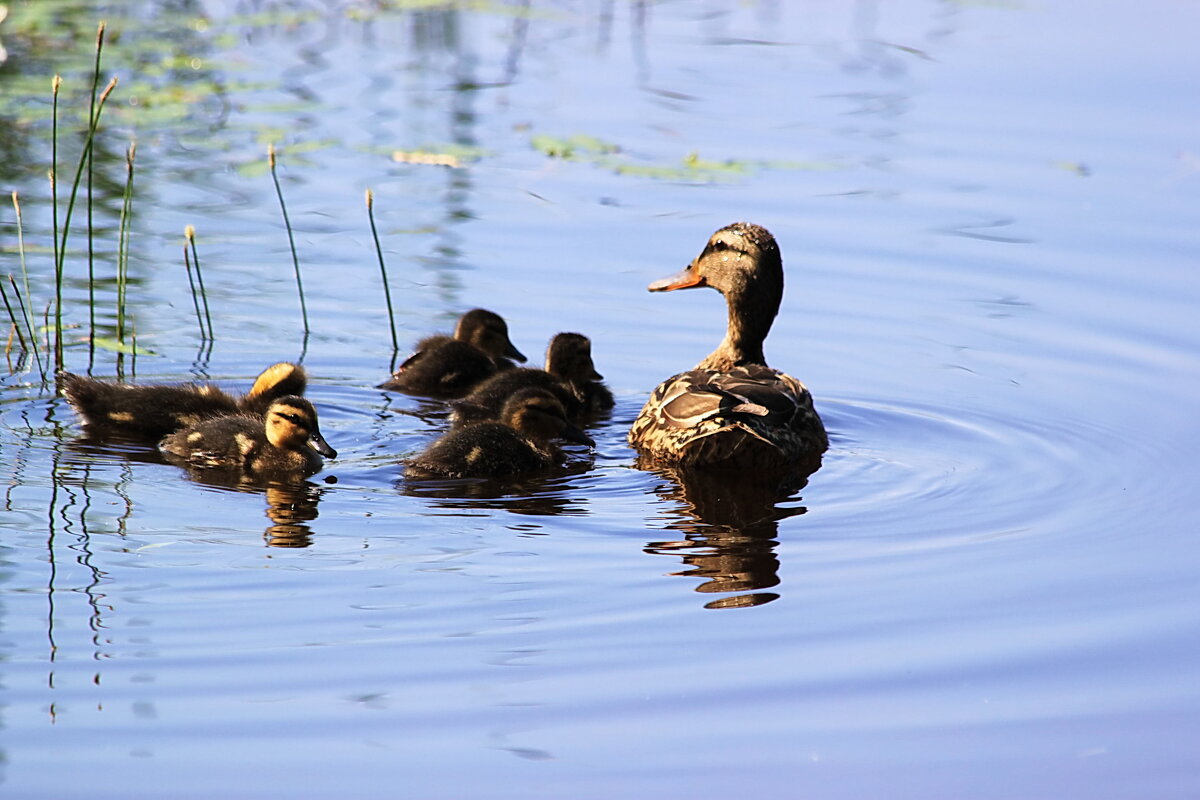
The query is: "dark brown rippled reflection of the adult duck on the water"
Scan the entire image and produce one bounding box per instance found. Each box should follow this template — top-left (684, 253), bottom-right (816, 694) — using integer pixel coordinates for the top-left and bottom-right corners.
top-left (638, 464), bottom-right (806, 608)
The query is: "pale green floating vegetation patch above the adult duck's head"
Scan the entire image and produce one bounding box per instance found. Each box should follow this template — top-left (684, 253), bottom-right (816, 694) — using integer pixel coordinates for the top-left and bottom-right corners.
top-left (529, 134), bottom-right (844, 184)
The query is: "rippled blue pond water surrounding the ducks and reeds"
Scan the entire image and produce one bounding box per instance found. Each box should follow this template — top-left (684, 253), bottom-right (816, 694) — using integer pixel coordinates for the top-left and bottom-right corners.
top-left (0, 0), bottom-right (1200, 799)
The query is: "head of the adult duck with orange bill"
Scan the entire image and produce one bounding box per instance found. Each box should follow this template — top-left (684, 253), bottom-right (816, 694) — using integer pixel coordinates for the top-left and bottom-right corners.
top-left (647, 222), bottom-right (784, 311)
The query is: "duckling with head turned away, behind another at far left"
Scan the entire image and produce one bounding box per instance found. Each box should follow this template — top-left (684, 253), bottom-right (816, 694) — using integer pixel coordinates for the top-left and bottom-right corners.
top-left (59, 362), bottom-right (308, 441)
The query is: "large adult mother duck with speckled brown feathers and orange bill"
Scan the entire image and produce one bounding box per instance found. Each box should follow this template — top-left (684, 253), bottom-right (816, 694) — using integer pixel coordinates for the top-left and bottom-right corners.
top-left (629, 222), bottom-right (829, 480)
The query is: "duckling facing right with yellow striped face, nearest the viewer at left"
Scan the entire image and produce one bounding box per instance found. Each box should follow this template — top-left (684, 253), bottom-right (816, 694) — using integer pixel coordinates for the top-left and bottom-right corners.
top-left (158, 396), bottom-right (337, 477)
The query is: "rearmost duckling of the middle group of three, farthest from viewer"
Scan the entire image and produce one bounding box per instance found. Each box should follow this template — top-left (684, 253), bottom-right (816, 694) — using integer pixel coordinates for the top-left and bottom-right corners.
top-left (377, 308), bottom-right (526, 399)
